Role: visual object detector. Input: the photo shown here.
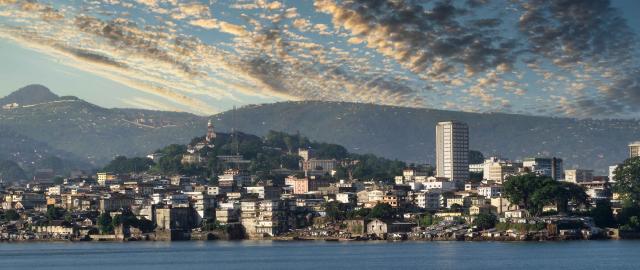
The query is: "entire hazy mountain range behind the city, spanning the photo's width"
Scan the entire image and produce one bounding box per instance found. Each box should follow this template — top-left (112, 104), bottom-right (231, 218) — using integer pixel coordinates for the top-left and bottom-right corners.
top-left (0, 85), bottom-right (640, 176)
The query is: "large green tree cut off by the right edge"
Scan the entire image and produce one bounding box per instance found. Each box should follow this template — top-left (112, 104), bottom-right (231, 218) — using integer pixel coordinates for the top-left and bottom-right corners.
top-left (613, 157), bottom-right (640, 205)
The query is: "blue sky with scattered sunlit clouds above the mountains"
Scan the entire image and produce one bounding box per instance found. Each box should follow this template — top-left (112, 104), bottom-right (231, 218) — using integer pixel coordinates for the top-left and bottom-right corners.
top-left (0, 0), bottom-right (640, 118)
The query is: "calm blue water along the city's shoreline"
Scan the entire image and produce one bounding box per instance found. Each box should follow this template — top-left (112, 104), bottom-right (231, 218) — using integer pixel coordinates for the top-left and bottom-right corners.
top-left (0, 241), bottom-right (640, 270)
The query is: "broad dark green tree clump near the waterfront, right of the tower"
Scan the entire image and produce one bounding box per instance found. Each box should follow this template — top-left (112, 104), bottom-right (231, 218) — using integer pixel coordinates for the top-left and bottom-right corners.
top-left (504, 173), bottom-right (588, 215)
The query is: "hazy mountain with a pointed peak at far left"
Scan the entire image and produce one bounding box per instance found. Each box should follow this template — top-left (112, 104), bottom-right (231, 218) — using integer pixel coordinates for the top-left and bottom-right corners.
top-left (0, 86), bottom-right (206, 167)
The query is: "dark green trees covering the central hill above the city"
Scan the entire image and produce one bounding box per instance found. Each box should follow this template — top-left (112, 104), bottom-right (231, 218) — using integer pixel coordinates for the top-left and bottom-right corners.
top-left (112, 131), bottom-right (406, 182)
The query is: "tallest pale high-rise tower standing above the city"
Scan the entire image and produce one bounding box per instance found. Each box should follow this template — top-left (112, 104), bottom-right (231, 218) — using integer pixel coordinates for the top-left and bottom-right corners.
top-left (436, 121), bottom-right (469, 187)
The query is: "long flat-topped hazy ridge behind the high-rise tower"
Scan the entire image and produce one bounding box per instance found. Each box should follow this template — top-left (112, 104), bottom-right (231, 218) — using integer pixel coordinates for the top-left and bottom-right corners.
top-left (211, 101), bottom-right (640, 173)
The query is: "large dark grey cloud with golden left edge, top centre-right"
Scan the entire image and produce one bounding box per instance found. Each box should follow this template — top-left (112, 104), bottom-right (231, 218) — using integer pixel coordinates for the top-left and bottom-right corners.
top-left (315, 0), bottom-right (516, 80)
